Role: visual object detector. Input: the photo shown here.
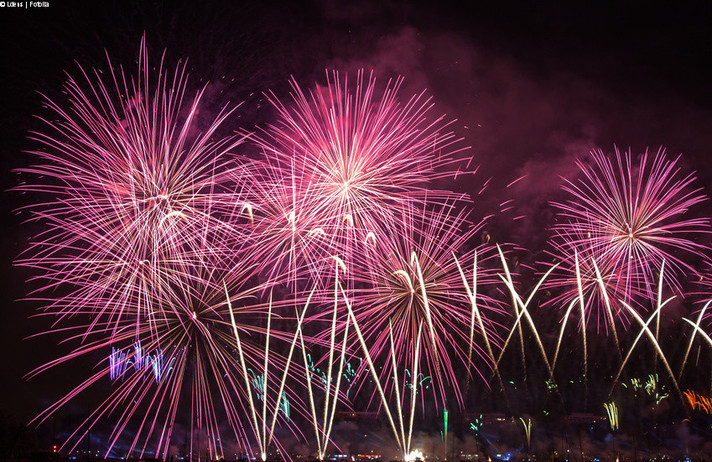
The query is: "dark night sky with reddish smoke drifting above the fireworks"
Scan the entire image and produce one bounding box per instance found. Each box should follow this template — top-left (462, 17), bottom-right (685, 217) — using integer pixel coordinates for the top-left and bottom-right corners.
top-left (0, 0), bottom-right (712, 450)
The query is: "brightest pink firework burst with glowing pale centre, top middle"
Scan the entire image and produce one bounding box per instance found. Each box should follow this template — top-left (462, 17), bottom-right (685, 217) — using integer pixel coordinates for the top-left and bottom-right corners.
top-left (255, 72), bottom-right (465, 244)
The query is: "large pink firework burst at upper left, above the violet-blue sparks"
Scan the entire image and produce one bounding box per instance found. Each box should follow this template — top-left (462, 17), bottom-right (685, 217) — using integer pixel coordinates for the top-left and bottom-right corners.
top-left (16, 37), bottom-right (250, 332)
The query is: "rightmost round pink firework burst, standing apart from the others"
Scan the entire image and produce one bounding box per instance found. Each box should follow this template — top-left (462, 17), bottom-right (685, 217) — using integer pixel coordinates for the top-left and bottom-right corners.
top-left (548, 149), bottom-right (709, 326)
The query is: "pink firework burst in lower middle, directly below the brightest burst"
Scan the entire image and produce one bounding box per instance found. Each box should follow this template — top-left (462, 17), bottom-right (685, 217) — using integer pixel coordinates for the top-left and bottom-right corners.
top-left (344, 202), bottom-right (502, 405)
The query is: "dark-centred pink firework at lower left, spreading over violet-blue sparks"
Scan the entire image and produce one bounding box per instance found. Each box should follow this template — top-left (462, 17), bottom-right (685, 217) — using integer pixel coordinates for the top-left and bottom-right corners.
top-left (26, 253), bottom-right (301, 457)
